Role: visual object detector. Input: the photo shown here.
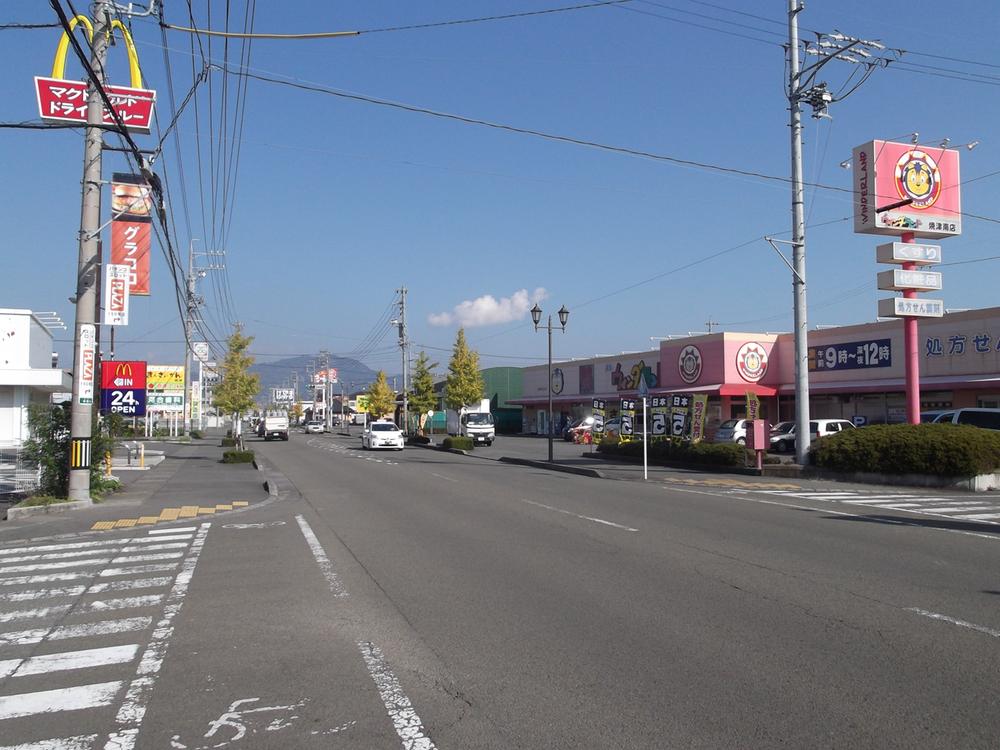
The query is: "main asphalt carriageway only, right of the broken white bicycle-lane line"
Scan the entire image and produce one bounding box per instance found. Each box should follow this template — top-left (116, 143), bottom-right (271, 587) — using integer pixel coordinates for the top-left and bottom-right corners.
top-left (252, 436), bottom-right (1000, 748)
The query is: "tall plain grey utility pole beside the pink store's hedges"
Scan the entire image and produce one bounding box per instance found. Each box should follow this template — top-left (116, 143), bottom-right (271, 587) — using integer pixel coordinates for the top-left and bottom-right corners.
top-left (788, 0), bottom-right (809, 464)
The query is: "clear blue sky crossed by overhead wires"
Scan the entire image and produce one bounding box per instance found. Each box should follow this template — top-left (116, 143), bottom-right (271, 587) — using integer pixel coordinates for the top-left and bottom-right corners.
top-left (0, 0), bottom-right (1000, 372)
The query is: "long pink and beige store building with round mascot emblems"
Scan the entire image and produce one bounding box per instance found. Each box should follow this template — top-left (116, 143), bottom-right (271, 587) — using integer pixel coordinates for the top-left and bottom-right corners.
top-left (515, 307), bottom-right (1000, 435)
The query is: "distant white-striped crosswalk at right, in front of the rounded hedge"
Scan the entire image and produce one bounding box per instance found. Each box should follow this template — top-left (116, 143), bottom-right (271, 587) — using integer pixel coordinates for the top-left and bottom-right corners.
top-left (755, 489), bottom-right (1000, 523)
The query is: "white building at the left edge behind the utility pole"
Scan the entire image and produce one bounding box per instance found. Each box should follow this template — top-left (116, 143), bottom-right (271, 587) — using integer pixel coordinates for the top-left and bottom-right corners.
top-left (0, 308), bottom-right (73, 448)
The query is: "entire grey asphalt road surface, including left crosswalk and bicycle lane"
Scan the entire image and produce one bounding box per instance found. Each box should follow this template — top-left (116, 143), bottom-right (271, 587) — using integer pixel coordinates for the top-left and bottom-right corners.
top-left (0, 434), bottom-right (1000, 750)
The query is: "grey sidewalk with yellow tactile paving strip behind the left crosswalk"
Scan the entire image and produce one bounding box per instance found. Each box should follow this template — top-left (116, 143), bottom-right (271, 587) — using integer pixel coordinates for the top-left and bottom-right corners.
top-left (0, 437), bottom-right (271, 542)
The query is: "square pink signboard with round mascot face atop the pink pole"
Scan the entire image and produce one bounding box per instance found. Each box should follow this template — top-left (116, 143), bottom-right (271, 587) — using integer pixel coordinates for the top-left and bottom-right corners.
top-left (851, 141), bottom-right (962, 238)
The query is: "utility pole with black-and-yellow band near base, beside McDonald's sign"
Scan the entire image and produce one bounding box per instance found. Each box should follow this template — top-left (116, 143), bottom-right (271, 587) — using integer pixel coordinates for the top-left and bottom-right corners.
top-left (68, 0), bottom-right (111, 501)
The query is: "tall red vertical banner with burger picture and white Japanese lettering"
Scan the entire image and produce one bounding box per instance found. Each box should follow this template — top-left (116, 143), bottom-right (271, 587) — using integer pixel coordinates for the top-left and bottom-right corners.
top-left (111, 173), bottom-right (153, 296)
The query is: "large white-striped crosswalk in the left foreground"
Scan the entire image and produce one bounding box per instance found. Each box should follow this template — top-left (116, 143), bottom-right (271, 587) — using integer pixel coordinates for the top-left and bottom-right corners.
top-left (0, 523), bottom-right (211, 750)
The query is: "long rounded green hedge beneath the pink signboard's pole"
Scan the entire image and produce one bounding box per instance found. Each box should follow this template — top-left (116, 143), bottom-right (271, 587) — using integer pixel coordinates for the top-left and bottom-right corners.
top-left (811, 424), bottom-right (1000, 477)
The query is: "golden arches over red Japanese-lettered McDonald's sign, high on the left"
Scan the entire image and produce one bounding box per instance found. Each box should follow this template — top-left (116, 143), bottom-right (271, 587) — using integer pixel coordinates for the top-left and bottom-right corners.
top-left (35, 16), bottom-right (156, 133)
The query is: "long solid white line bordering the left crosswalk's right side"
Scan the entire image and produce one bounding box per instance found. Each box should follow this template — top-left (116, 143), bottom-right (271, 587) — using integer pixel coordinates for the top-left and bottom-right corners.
top-left (104, 523), bottom-right (212, 750)
